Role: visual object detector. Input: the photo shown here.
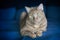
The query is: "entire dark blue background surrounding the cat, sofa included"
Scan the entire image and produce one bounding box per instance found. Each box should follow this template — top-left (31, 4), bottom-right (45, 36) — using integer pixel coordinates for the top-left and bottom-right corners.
top-left (0, 0), bottom-right (60, 40)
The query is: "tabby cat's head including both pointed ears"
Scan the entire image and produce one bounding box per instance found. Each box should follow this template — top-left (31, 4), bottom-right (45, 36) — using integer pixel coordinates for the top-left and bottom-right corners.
top-left (25, 3), bottom-right (44, 22)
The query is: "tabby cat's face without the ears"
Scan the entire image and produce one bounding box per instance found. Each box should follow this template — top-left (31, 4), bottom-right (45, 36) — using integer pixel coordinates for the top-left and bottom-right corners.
top-left (29, 9), bottom-right (43, 23)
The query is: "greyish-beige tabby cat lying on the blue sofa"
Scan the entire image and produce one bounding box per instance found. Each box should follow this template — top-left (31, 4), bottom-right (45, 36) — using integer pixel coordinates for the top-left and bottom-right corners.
top-left (20, 3), bottom-right (47, 38)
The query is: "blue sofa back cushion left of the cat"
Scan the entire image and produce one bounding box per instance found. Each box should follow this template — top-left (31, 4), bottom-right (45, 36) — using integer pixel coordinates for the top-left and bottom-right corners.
top-left (0, 7), bottom-right (16, 20)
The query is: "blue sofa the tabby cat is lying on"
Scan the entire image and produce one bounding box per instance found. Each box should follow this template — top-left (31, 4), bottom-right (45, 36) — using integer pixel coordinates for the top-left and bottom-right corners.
top-left (0, 0), bottom-right (60, 40)
